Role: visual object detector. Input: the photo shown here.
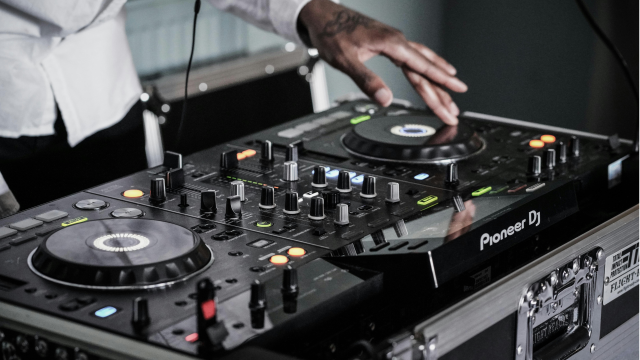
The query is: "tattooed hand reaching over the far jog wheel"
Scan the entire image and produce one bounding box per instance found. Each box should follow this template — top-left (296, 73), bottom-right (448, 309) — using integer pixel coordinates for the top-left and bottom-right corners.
top-left (299, 0), bottom-right (467, 125)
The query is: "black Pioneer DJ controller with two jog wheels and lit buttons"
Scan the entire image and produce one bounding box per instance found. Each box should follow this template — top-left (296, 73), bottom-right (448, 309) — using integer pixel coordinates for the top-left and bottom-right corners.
top-left (0, 101), bottom-right (638, 359)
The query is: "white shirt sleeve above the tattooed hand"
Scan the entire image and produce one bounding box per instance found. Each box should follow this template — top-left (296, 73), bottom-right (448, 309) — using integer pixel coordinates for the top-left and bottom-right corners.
top-left (209, 0), bottom-right (311, 44)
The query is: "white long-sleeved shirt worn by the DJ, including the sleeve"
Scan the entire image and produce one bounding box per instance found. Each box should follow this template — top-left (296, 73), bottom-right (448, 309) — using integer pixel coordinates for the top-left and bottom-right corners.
top-left (0, 0), bottom-right (310, 146)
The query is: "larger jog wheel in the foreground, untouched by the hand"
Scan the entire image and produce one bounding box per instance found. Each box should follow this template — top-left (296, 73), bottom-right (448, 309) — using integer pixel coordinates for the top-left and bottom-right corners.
top-left (28, 219), bottom-right (213, 290)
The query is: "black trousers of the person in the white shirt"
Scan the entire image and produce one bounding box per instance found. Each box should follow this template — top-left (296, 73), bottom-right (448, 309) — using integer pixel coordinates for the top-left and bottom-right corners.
top-left (0, 102), bottom-right (147, 210)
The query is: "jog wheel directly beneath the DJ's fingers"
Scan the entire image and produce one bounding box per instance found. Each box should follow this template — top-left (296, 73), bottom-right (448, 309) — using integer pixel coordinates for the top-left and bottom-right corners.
top-left (341, 115), bottom-right (484, 164)
